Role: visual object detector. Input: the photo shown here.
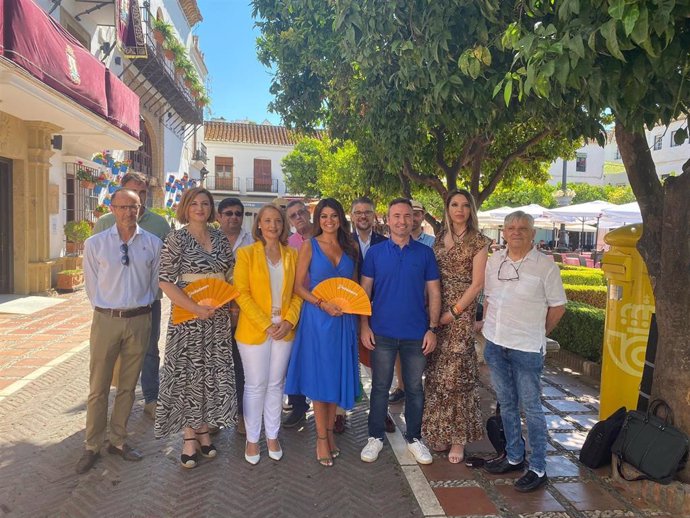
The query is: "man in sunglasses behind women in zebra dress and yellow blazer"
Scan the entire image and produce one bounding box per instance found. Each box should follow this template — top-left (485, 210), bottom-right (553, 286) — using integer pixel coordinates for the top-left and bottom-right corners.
top-left (216, 198), bottom-right (254, 435)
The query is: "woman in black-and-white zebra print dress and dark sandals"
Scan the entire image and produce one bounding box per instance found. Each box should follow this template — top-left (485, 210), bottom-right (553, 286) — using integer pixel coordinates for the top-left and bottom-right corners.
top-left (155, 188), bottom-right (237, 468)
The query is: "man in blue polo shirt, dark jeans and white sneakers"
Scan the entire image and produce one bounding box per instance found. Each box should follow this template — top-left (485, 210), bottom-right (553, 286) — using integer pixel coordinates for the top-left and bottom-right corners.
top-left (360, 198), bottom-right (441, 464)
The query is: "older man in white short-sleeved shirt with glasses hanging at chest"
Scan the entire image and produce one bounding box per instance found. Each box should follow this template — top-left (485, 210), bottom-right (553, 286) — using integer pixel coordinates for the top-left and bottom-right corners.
top-left (484, 211), bottom-right (566, 492)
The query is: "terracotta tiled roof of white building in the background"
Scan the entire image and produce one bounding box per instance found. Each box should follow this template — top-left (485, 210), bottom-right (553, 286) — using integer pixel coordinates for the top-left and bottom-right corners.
top-left (204, 121), bottom-right (321, 146)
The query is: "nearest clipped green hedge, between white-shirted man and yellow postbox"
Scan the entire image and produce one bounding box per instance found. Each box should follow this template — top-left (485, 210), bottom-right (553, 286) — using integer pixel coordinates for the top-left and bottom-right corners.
top-left (550, 302), bottom-right (605, 363)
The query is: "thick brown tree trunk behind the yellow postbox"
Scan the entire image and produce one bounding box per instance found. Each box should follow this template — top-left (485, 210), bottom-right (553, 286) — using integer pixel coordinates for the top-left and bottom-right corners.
top-left (616, 122), bottom-right (690, 482)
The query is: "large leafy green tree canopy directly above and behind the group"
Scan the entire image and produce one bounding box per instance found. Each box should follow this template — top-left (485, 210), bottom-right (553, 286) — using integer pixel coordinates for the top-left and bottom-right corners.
top-left (253, 0), bottom-right (601, 210)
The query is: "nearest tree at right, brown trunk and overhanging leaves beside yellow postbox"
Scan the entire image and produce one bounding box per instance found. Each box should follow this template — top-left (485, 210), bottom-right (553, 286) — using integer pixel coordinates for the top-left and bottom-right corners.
top-left (502, 0), bottom-right (690, 481)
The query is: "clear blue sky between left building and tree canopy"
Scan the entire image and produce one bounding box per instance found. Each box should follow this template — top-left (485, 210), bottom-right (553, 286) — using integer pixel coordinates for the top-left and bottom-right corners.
top-left (194, 0), bottom-right (280, 124)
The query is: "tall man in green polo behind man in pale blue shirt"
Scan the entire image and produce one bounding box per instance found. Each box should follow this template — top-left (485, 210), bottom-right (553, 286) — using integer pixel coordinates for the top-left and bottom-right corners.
top-left (93, 172), bottom-right (170, 419)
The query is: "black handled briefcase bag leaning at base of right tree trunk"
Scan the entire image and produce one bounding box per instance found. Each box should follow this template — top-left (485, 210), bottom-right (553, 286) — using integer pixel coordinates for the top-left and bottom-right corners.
top-left (612, 399), bottom-right (688, 484)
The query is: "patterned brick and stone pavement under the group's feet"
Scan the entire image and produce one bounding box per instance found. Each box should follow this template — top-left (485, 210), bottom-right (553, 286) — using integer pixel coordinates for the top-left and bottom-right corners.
top-left (0, 292), bottom-right (670, 518)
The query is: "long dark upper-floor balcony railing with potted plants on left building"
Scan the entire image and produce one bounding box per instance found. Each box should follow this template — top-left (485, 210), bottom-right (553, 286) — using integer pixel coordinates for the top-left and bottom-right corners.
top-left (131, 6), bottom-right (203, 124)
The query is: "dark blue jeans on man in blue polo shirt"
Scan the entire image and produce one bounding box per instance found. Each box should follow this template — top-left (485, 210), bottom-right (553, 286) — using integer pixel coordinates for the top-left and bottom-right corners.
top-left (369, 335), bottom-right (426, 442)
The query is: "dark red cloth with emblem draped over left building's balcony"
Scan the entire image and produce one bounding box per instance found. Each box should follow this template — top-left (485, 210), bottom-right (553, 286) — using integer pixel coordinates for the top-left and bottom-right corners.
top-left (0, 0), bottom-right (139, 138)
